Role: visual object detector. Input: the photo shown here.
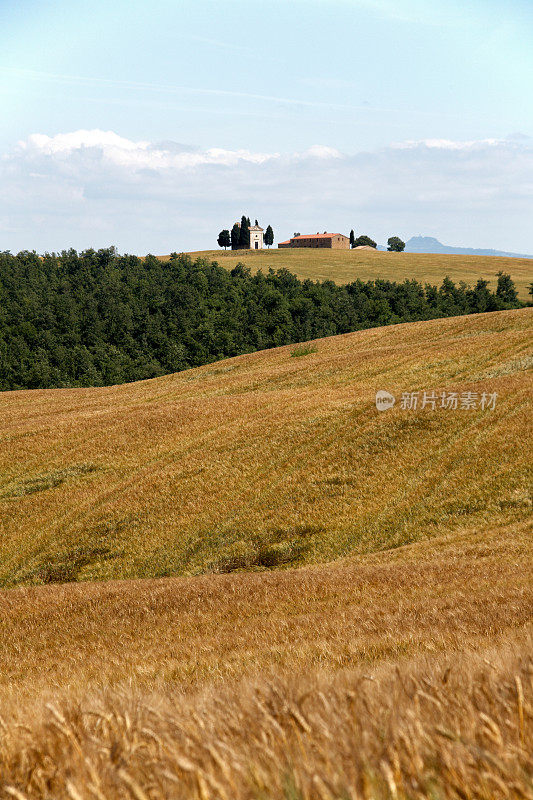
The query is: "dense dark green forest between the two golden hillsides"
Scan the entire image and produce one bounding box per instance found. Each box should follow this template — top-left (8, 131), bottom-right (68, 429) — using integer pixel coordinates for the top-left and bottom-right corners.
top-left (0, 248), bottom-right (521, 390)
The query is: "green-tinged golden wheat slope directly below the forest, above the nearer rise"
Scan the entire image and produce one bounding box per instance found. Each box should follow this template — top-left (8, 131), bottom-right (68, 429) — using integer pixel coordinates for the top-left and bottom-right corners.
top-left (0, 309), bottom-right (533, 586)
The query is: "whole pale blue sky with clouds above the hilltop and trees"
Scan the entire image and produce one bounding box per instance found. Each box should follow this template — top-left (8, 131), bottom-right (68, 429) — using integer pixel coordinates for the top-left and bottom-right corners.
top-left (0, 0), bottom-right (533, 254)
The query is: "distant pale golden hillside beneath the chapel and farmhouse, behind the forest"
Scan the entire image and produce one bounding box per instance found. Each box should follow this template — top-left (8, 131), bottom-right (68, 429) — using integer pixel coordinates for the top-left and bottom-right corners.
top-left (180, 246), bottom-right (533, 301)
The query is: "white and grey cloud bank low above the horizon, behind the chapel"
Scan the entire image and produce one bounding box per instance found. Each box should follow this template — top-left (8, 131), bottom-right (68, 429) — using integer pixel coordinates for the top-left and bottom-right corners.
top-left (0, 130), bottom-right (533, 253)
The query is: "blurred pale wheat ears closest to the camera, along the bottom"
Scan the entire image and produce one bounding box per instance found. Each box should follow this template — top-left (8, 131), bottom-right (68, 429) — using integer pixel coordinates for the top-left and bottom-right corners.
top-left (0, 636), bottom-right (533, 800)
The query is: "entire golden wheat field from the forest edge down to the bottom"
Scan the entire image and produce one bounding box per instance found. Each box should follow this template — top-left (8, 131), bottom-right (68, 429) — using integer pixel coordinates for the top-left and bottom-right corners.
top-left (0, 309), bottom-right (533, 800)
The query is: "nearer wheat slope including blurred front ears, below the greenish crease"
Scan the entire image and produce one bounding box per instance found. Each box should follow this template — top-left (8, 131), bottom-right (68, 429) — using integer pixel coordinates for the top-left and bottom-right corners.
top-left (0, 524), bottom-right (533, 800)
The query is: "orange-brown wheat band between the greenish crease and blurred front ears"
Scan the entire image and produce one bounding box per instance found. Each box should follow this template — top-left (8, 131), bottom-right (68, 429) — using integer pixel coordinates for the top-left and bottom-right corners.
top-left (0, 522), bottom-right (533, 702)
